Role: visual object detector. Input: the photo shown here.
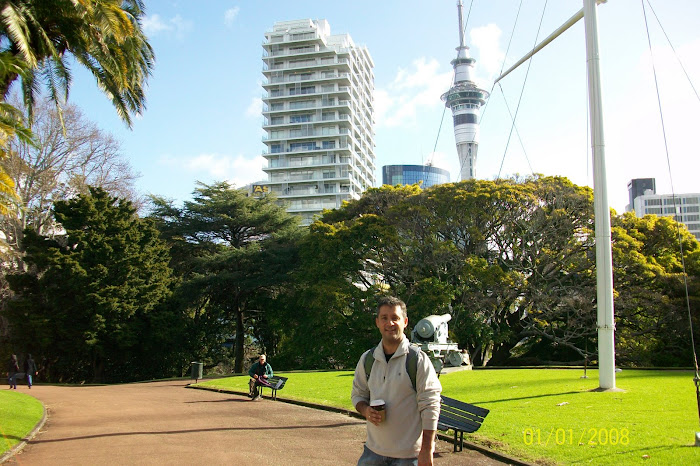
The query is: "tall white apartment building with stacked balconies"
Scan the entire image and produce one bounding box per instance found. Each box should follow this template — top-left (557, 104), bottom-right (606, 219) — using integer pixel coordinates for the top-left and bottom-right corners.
top-left (263, 19), bottom-right (375, 225)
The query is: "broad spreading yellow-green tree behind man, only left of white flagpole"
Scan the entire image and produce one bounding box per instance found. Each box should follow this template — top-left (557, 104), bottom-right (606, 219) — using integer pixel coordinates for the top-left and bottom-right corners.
top-left (290, 177), bottom-right (594, 364)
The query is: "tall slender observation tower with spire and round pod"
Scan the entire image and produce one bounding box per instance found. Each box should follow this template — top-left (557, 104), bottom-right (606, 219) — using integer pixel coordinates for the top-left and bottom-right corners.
top-left (441, 0), bottom-right (489, 180)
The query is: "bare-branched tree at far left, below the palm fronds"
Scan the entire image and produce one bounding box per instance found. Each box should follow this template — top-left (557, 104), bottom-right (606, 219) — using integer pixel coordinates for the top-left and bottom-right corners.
top-left (0, 101), bottom-right (138, 268)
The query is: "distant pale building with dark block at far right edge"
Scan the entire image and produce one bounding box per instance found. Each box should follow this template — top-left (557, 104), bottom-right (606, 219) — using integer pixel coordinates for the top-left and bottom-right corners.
top-left (626, 178), bottom-right (700, 239)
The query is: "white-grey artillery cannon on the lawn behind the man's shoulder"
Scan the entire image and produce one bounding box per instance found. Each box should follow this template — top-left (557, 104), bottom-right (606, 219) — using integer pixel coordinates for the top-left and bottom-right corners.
top-left (411, 314), bottom-right (470, 374)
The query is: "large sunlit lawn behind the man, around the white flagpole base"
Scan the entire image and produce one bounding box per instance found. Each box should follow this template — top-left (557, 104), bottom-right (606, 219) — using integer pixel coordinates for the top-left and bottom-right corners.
top-left (200, 369), bottom-right (700, 465)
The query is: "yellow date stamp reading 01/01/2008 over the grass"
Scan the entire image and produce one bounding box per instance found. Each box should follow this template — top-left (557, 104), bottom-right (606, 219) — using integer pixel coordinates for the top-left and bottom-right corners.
top-left (523, 427), bottom-right (630, 447)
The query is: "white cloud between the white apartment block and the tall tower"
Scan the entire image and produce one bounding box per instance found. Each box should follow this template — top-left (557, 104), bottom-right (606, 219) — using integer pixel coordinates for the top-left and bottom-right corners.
top-left (374, 57), bottom-right (452, 127)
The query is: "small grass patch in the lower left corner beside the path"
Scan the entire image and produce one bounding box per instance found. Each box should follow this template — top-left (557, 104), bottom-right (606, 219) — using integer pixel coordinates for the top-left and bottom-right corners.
top-left (0, 390), bottom-right (44, 456)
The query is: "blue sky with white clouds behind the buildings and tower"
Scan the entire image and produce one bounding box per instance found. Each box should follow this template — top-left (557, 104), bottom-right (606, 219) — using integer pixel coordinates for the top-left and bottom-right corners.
top-left (65, 0), bottom-right (700, 212)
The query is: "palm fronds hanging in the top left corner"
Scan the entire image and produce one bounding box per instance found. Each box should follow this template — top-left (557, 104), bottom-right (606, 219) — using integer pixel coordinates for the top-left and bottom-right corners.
top-left (0, 0), bottom-right (155, 126)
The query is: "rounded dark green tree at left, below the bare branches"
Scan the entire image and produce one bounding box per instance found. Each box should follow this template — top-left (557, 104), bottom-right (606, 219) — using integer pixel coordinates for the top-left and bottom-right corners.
top-left (7, 188), bottom-right (173, 381)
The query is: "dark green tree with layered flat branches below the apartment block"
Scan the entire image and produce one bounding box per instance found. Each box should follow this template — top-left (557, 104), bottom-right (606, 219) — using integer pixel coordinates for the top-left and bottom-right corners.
top-left (148, 182), bottom-right (301, 372)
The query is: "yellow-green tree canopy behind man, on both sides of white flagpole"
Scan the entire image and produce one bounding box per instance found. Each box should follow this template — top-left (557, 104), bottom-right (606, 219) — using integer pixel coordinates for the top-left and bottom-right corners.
top-left (281, 177), bottom-right (698, 366)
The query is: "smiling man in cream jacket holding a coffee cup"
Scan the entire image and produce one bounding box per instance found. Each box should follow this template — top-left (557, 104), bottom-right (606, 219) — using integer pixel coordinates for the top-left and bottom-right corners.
top-left (352, 297), bottom-right (442, 466)
